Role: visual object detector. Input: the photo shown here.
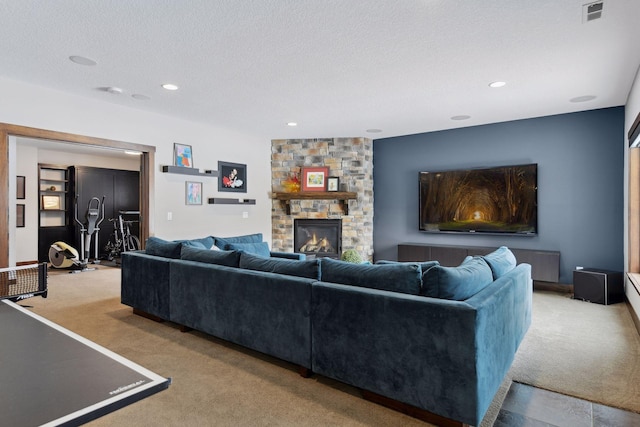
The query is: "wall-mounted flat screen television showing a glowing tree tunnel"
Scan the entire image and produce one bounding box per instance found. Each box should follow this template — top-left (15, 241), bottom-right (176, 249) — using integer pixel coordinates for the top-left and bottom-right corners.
top-left (419, 164), bottom-right (538, 236)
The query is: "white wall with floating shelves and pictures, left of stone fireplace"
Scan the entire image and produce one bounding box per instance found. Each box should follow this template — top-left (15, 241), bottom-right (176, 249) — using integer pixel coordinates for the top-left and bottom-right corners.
top-left (0, 78), bottom-right (271, 260)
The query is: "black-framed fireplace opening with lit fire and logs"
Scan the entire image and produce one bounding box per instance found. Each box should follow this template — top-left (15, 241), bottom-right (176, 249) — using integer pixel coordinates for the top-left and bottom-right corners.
top-left (293, 219), bottom-right (342, 259)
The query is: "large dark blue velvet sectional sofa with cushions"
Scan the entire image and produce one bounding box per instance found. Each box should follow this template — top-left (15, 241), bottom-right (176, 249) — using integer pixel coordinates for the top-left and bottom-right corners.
top-left (122, 236), bottom-right (532, 425)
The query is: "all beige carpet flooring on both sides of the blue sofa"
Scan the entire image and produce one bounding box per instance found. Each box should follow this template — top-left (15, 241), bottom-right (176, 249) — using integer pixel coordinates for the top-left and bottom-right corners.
top-left (21, 266), bottom-right (640, 427)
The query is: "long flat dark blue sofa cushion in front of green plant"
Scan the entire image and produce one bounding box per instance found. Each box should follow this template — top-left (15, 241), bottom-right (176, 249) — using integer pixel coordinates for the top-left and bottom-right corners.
top-left (320, 258), bottom-right (422, 295)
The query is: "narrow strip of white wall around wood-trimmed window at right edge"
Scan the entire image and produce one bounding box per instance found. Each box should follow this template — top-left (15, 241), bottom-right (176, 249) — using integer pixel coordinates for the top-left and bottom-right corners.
top-left (624, 63), bottom-right (640, 324)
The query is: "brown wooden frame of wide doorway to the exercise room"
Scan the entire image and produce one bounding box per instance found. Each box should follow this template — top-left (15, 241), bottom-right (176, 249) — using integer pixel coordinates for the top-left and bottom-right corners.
top-left (0, 123), bottom-right (156, 268)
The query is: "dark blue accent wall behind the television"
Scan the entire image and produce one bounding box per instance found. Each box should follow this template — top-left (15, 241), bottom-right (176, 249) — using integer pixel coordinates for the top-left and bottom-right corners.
top-left (373, 107), bottom-right (624, 283)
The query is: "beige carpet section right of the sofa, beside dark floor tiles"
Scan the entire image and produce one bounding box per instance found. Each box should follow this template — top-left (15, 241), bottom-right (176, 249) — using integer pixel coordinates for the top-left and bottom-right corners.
top-left (509, 291), bottom-right (640, 413)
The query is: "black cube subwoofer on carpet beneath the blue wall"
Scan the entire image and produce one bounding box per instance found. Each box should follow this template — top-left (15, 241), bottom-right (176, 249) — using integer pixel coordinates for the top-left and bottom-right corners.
top-left (573, 268), bottom-right (624, 305)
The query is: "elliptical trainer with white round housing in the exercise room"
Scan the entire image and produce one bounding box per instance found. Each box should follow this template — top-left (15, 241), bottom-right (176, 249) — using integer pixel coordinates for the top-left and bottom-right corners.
top-left (49, 195), bottom-right (105, 273)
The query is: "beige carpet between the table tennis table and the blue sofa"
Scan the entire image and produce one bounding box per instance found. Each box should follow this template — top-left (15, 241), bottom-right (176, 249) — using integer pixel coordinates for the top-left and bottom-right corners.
top-left (27, 266), bottom-right (510, 426)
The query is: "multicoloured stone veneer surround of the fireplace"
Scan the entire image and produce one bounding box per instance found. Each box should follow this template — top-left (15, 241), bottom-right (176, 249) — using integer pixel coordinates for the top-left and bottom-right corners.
top-left (271, 138), bottom-right (373, 260)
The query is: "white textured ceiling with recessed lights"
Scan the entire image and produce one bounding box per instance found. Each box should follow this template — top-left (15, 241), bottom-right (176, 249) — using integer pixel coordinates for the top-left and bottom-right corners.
top-left (0, 0), bottom-right (640, 140)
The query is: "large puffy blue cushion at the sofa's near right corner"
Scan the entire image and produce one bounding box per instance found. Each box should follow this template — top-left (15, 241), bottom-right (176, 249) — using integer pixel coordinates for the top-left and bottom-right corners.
top-left (422, 257), bottom-right (493, 301)
